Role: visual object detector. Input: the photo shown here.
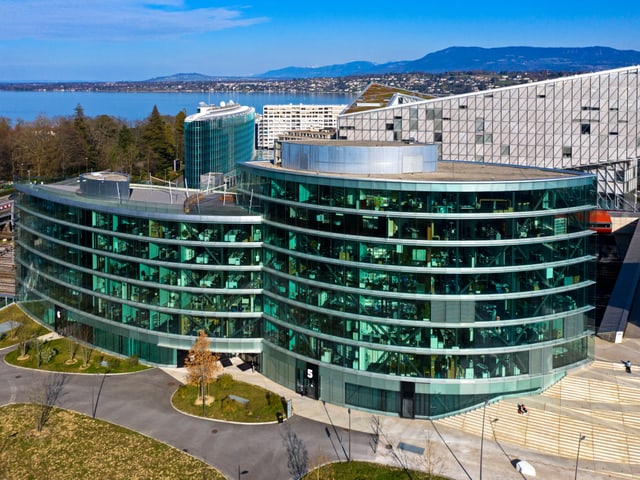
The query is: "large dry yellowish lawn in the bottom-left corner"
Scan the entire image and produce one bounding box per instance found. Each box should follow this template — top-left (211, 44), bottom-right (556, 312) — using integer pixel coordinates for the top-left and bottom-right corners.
top-left (0, 404), bottom-right (224, 480)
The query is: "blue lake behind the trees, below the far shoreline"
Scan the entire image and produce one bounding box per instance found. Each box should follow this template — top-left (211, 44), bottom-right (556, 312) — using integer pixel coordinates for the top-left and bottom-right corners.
top-left (0, 91), bottom-right (355, 124)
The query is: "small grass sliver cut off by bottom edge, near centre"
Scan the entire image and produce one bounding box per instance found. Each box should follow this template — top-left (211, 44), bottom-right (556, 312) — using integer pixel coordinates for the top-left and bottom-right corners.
top-left (302, 462), bottom-right (447, 480)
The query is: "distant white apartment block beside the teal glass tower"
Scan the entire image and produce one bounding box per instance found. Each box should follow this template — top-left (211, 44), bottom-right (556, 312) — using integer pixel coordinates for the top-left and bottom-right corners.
top-left (257, 104), bottom-right (346, 149)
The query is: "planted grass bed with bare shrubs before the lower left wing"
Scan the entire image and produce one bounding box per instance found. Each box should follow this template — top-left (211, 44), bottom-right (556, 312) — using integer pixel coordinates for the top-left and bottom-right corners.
top-left (5, 338), bottom-right (150, 373)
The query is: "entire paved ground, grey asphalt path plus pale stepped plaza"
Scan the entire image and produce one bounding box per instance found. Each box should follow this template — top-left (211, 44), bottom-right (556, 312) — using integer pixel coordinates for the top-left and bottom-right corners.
top-left (0, 325), bottom-right (640, 480)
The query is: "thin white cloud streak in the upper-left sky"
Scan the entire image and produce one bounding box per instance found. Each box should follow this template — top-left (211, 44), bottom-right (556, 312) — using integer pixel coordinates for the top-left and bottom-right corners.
top-left (0, 0), bottom-right (268, 41)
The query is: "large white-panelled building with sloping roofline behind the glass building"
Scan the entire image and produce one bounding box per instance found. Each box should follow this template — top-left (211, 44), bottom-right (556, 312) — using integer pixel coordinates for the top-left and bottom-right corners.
top-left (338, 66), bottom-right (640, 209)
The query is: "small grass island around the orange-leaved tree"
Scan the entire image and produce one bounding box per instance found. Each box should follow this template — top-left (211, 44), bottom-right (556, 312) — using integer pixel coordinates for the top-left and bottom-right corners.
top-left (172, 374), bottom-right (285, 423)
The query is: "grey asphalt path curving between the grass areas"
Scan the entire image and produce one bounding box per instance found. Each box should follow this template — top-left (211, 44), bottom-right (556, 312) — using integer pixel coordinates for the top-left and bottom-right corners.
top-left (0, 350), bottom-right (375, 480)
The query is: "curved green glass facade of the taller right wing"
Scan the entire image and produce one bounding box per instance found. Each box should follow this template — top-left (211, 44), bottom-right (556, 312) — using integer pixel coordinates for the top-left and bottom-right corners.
top-left (240, 153), bottom-right (596, 417)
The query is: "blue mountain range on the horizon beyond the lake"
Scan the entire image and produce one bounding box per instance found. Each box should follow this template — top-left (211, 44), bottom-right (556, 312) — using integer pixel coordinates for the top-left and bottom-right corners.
top-left (149, 47), bottom-right (640, 82)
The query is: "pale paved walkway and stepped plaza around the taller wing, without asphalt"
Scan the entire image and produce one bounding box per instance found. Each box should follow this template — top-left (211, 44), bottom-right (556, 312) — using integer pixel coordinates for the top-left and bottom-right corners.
top-left (165, 325), bottom-right (640, 480)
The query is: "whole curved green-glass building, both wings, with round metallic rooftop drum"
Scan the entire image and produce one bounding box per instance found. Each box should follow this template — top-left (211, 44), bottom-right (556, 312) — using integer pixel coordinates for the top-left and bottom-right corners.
top-left (16, 141), bottom-right (596, 418)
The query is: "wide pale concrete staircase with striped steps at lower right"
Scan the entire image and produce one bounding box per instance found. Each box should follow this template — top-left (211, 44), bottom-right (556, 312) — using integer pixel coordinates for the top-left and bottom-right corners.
top-left (436, 360), bottom-right (640, 478)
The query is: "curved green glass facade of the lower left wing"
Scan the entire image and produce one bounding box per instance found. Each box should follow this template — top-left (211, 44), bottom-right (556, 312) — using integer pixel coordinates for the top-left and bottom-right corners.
top-left (16, 185), bottom-right (262, 365)
